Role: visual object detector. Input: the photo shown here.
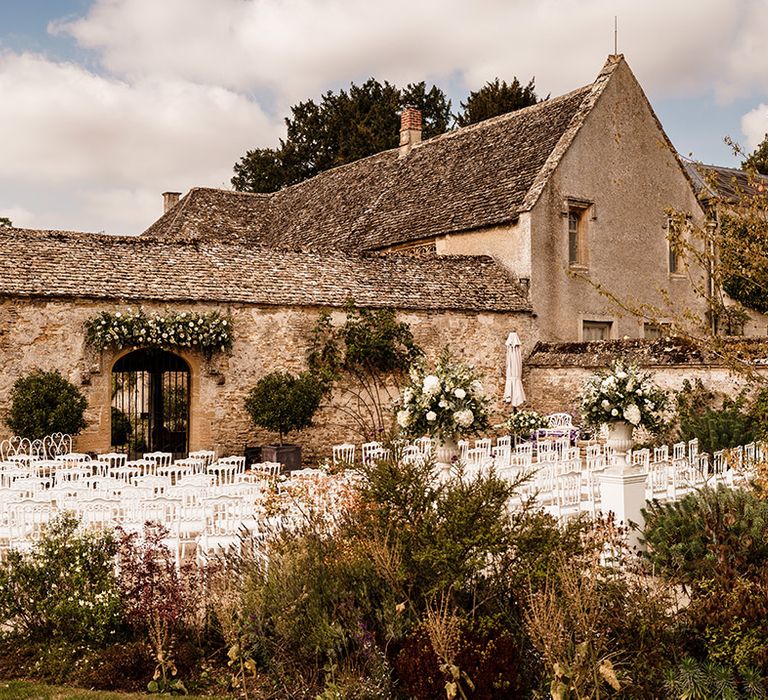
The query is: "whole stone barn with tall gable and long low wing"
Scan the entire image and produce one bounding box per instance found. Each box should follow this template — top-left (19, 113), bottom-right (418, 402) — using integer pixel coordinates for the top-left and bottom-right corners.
top-left (0, 56), bottom-right (703, 460)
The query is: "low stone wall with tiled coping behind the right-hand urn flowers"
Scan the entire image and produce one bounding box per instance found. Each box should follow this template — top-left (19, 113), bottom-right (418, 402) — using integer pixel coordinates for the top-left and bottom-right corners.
top-left (523, 338), bottom-right (768, 422)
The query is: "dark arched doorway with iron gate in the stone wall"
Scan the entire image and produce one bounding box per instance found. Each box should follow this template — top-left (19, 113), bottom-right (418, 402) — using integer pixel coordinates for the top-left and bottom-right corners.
top-left (112, 348), bottom-right (190, 459)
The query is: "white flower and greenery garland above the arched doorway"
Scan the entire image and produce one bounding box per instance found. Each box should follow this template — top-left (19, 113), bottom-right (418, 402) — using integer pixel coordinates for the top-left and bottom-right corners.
top-left (85, 309), bottom-right (232, 357)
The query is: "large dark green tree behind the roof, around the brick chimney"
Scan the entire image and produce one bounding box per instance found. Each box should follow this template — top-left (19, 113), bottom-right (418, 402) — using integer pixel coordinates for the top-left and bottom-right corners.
top-left (232, 78), bottom-right (451, 192)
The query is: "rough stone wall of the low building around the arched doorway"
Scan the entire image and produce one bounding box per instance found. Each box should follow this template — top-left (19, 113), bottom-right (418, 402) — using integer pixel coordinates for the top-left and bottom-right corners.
top-left (0, 299), bottom-right (537, 459)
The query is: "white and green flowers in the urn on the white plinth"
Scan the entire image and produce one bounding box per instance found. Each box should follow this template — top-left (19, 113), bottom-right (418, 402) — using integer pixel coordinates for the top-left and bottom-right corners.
top-left (580, 360), bottom-right (667, 433)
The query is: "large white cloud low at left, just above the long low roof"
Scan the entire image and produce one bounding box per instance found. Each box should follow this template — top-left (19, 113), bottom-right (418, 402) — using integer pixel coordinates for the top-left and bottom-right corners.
top-left (0, 52), bottom-right (279, 232)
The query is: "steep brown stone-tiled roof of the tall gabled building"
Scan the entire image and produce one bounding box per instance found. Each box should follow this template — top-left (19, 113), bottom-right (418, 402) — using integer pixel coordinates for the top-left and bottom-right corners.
top-left (144, 57), bottom-right (623, 252)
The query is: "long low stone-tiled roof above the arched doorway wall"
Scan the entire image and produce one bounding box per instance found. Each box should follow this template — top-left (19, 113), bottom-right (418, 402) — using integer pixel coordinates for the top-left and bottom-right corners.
top-left (0, 228), bottom-right (530, 311)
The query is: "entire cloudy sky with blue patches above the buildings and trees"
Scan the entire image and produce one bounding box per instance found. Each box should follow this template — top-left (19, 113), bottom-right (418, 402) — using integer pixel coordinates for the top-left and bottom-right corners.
top-left (0, 0), bottom-right (768, 235)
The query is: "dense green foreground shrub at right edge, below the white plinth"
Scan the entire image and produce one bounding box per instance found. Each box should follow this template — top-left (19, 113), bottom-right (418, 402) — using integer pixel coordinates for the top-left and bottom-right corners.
top-left (643, 484), bottom-right (768, 584)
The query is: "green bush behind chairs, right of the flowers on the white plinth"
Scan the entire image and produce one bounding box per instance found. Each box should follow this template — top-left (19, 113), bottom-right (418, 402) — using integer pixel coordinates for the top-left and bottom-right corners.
top-left (675, 379), bottom-right (762, 454)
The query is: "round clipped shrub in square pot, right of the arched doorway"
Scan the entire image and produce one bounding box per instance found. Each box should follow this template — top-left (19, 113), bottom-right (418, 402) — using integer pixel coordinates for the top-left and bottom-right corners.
top-left (245, 372), bottom-right (324, 471)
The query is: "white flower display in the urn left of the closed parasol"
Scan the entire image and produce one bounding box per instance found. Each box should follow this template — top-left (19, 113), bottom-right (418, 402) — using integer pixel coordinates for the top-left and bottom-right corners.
top-left (395, 349), bottom-right (489, 441)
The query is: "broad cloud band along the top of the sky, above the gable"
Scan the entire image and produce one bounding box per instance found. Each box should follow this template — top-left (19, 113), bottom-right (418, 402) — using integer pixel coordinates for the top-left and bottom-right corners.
top-left (52, 0), bottom-right (768, 105)
